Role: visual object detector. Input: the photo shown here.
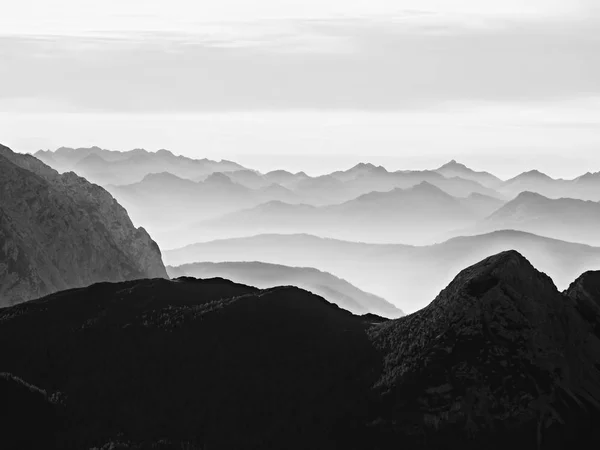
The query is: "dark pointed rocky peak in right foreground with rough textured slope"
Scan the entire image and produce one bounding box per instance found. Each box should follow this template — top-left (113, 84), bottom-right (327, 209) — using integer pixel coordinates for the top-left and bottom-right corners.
top-left (373, 251), bottom-right (600, 448)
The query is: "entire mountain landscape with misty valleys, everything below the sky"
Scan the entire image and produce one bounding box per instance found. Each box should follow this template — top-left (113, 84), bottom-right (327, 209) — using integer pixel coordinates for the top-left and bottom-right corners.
top-left (0, 145), bottom-right (600, 450)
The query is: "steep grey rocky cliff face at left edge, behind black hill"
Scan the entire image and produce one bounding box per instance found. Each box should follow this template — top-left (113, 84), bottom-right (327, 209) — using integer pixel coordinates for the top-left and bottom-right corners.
top-left (0, 145), bottom-right (167, 306)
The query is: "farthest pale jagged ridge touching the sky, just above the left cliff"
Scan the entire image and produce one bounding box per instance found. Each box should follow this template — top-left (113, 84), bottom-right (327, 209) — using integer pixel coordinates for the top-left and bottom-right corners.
top-left (34, 147), bottom-right (244, 186)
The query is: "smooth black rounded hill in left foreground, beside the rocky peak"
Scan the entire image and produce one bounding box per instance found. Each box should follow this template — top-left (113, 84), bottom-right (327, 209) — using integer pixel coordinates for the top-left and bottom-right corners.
top-left (0, 278), bottom-right (379, 449)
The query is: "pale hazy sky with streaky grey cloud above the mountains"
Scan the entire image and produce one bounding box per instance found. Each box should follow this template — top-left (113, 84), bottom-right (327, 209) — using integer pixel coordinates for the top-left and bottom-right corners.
top-left (0, 0), bottom-right (600, 177)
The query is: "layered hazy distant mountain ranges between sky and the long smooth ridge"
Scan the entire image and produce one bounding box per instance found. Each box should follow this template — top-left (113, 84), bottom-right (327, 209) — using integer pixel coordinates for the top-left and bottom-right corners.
top-left (36, 147), bottom-right (600, 248)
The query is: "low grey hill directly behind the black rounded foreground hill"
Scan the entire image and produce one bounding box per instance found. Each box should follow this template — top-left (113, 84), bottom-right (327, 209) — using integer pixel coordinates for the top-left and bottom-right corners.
top-left (167, 261), bottom-right (403, 318)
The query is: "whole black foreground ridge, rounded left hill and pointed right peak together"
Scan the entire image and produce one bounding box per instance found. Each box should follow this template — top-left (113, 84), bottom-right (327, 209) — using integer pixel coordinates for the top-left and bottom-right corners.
top-left (0, 255), bottom-right (600, 449)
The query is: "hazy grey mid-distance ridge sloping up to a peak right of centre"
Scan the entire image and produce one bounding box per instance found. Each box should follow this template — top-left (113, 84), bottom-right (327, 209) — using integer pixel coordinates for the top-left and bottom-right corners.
top-left (176, 181), bottom-right (483, 248)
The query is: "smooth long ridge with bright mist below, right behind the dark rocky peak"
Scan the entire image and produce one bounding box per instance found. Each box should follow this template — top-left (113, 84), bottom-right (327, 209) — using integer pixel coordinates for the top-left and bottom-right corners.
top-left (164, 231), bottom-right (600, 312)
